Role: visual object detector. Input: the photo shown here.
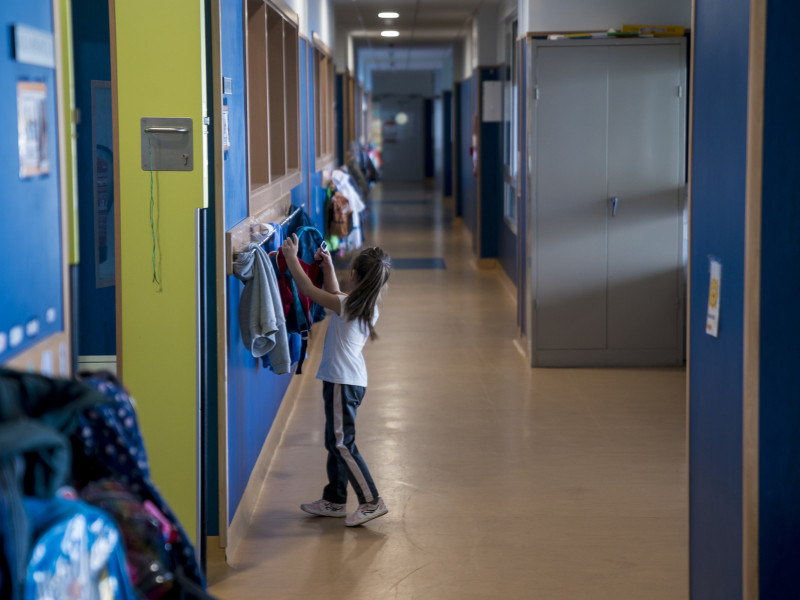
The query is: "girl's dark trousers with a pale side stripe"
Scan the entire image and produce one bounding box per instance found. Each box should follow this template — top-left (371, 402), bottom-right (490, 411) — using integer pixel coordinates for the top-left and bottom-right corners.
top-left (322, 381), bottom-right (378, 504)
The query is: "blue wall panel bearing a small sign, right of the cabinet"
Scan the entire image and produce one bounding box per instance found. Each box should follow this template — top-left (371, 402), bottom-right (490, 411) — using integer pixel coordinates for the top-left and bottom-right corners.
top-left (689, 0), bottom-right (750, 600)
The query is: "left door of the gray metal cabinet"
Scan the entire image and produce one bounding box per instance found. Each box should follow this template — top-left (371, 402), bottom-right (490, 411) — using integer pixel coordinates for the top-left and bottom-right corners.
top-left (532, 47), bottom-right (608, 350)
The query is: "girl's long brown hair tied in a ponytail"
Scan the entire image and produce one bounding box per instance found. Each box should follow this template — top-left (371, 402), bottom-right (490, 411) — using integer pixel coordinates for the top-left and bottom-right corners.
top-left (345, 246), bottom-right (392, 340)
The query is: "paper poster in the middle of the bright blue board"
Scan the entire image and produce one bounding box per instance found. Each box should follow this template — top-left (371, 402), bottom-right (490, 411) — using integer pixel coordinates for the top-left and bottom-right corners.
top-left (17, 81), bottom-right (50, 179)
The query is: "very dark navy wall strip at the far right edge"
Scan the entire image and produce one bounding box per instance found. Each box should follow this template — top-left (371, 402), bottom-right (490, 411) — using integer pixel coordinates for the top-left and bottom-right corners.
top-left (759, 2), bottom-right (800, 598)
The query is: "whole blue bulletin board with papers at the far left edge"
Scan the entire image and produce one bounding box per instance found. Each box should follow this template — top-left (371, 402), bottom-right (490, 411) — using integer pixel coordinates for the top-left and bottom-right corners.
top-left (0, 5), bottom-right (71, 375)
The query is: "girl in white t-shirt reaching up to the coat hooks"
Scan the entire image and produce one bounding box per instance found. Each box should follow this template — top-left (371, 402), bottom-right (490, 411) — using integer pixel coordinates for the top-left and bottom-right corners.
top-left (281, 234), bottom-right (392, 527)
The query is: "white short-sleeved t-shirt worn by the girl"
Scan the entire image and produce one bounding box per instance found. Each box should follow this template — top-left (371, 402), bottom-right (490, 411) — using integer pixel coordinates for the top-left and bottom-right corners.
top-left (317, 295), bottom-right (378, 387)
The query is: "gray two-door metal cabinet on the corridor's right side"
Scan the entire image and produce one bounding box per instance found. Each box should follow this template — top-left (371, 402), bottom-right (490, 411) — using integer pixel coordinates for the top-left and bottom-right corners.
top-left (528, 38), bottom-right (686, 366)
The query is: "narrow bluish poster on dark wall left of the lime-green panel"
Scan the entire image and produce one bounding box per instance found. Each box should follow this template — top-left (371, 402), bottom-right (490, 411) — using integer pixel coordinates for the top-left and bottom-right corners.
top-left (92, 81), bottom-right (115, 288)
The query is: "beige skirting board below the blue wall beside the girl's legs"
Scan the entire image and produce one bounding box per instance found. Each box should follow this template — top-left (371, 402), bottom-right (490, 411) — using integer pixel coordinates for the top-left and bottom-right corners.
top-left (225, 320), bottom-right (329, 564)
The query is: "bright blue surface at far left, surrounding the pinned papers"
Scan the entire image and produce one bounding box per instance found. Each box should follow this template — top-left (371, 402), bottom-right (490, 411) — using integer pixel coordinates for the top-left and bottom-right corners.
top-left (0, 0), bottom-right (65, 363)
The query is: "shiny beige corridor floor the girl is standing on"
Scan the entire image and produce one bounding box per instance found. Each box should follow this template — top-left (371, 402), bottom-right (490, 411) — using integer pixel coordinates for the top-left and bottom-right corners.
top-left (209, 185), bottom-right (688, 600)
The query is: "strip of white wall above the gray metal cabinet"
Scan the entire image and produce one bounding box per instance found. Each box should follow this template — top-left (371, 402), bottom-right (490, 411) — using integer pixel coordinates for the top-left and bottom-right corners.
top-left (519, 0), bottom-right (692, 33)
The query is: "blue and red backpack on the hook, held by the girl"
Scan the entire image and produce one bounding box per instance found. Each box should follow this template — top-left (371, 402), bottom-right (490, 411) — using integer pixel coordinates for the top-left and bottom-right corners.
top-left (269, 226), bottom-right (325, 375)
